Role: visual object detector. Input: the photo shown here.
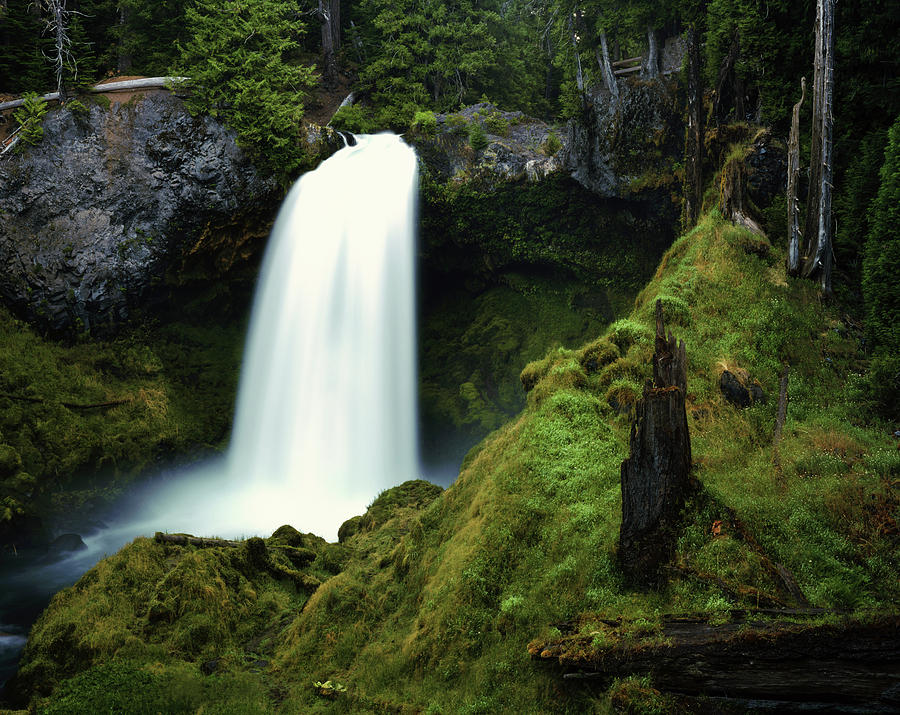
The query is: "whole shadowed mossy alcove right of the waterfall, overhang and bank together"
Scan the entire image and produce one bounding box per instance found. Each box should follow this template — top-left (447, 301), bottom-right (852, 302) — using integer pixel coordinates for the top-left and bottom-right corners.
top-left (419, 172), bottom-right (674, 463)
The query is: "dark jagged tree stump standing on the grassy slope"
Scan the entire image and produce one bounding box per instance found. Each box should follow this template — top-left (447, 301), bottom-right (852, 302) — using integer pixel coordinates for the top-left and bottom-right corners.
top-left (618, 301), bottom-right (691, 588)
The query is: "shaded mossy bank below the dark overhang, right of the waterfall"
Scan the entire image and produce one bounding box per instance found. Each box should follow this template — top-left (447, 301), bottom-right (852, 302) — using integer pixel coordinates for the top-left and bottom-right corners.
top-left (419, 274), bottom-right (612, 465)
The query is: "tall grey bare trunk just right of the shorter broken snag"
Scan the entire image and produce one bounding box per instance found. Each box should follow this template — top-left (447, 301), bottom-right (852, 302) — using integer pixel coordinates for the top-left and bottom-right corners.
top-left (803, 0), bottom-right (834, 293)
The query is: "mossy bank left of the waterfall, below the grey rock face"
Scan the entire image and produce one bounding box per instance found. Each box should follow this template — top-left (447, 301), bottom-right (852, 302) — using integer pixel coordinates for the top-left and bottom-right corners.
top-left (0, 309), bottom-right (243, 545)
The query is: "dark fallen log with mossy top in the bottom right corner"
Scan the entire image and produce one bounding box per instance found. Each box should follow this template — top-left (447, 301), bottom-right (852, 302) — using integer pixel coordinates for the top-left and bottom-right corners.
top-left (528, 609), bottom-right (900, 713)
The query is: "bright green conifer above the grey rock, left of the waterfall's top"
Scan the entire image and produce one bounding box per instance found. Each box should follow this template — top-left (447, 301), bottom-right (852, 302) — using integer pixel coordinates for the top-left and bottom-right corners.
top-left (177, 0), bottom-right (315, 179)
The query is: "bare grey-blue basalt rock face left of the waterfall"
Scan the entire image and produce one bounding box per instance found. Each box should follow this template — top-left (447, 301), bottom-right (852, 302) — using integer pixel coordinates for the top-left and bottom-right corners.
top-left (0, 92), bottom-right (281, 333)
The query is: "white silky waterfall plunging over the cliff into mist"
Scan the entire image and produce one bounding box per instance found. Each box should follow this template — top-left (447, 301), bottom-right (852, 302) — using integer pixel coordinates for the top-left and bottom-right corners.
top-left (139, 134), bottom-right (418, 540)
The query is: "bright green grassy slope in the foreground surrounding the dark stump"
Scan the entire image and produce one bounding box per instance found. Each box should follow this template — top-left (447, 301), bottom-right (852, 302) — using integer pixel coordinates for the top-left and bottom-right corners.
top-left (15, 214), bottom-right (900, 713)
